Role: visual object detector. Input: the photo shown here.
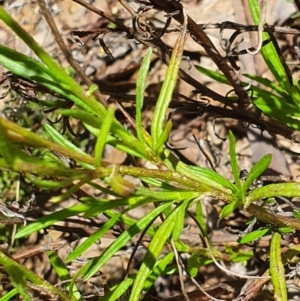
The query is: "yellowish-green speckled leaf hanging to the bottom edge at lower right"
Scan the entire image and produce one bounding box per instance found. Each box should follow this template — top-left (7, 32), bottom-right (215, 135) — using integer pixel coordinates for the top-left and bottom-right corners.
top-left (270, 232), bottom-right (288, 301)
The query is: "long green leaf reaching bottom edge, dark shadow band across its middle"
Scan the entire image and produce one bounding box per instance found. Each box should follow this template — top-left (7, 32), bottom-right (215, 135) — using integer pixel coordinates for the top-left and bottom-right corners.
top-left (129, 206), bottom-right (181, 301)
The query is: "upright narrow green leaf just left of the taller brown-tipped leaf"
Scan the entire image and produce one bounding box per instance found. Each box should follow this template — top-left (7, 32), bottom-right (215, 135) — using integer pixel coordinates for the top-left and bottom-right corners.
top-left (135, 47), bottom-right (152, 147)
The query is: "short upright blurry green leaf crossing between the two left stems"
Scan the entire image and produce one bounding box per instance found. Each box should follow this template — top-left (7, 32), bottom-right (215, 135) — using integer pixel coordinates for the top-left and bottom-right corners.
top-left (95, 106), bottom-right (115, 167)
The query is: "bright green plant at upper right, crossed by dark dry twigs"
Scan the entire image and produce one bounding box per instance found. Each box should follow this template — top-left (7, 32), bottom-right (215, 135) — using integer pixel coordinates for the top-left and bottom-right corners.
top-left (196, 0), bottom-right (300, 130)
